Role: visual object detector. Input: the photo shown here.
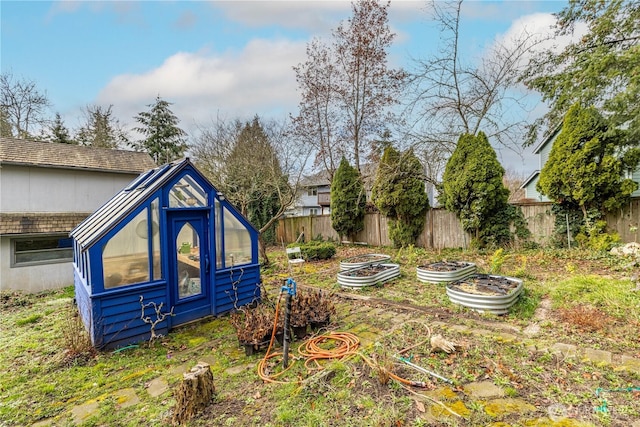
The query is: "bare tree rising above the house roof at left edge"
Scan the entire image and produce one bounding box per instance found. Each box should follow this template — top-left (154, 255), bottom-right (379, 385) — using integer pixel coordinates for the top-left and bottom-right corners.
top-left (0, 73), bottom-right (51, 138)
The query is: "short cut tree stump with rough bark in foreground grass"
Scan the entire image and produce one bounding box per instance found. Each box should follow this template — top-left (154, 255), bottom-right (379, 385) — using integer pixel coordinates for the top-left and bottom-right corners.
top-left (172, 362), bottom-right (216, 425)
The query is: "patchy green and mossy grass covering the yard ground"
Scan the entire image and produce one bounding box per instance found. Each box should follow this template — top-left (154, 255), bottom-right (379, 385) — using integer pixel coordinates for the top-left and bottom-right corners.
top-left (0, 247), bottom-right (640, 426)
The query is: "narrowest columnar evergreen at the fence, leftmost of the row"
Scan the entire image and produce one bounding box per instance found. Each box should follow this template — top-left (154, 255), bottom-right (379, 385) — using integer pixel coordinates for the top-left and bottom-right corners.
top-left (331, 157), bottom-right (366, 244)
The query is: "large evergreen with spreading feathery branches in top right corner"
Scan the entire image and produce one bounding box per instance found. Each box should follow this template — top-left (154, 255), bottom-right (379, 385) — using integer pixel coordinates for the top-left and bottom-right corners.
top-left (521, 0), bottom-right (640, 145)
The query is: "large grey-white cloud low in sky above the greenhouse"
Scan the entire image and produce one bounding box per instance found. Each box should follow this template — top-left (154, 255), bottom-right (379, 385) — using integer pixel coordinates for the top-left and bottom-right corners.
top-left (97, 39), bottom-right (306, 132)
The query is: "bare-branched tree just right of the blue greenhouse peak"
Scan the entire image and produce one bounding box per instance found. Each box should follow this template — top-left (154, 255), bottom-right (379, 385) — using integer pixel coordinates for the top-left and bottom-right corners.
top-left (191, 117), bottom-right (312, 263)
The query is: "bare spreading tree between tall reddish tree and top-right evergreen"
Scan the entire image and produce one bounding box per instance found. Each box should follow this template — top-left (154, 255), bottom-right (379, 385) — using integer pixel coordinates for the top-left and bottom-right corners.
top-left (405, 0), bottom-right (542, 181)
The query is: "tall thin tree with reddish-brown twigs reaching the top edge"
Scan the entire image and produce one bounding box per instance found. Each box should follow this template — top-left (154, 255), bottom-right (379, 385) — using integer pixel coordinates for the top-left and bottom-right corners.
top-left (294, 0), bottom-right (406, 176)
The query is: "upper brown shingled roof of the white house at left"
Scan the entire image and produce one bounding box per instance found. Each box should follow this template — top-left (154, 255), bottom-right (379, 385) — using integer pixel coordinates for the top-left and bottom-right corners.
top-left (0, 138), bottom-right (156, 173)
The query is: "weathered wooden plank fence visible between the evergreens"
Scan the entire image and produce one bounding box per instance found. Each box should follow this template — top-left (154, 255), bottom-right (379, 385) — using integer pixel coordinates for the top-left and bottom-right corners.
top-left (276, 199), bottom-right (640, 250)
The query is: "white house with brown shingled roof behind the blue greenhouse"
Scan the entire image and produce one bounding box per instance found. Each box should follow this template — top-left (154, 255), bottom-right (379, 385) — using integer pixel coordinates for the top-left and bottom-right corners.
top-left (0, 138), bottom-right (155, 292)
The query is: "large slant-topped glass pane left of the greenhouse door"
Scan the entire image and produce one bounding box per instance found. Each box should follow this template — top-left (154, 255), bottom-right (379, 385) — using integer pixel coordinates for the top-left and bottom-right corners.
top-left (102, 208), bottom-right (149, 289)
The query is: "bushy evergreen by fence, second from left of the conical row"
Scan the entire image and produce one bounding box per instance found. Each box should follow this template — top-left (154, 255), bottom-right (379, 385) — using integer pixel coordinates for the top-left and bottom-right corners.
top-left (372, 145), bottom-right (429, 247)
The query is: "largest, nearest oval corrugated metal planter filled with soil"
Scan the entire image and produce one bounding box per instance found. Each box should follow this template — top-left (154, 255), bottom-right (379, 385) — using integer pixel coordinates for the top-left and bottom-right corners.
top-left (447, 274), bottom-right (523, 314)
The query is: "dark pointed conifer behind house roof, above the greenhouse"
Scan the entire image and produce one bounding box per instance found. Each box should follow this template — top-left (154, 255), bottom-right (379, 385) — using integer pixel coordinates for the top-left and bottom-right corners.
top-left (130, 96), bottom-right (187, 165)
